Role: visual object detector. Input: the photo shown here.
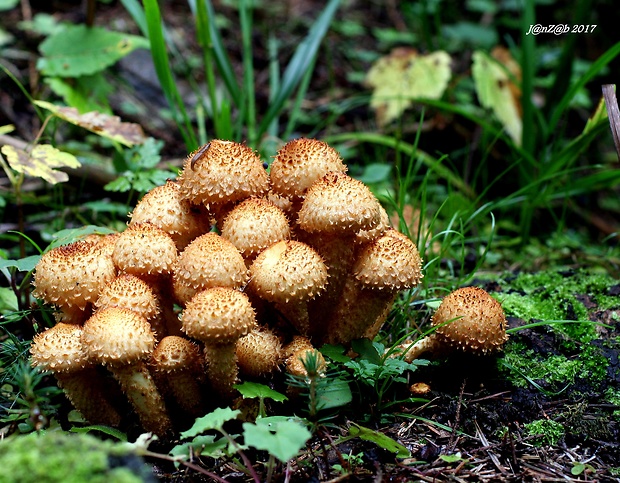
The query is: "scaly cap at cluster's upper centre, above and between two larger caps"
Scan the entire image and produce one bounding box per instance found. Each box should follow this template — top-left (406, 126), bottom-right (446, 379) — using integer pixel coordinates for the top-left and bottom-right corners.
top-left (222, 198), bottom-right (291, 259)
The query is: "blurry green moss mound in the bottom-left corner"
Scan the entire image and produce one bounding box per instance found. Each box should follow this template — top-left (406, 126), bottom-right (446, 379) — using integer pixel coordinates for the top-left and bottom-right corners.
top-left (0, 431), bottom-right (150, 483)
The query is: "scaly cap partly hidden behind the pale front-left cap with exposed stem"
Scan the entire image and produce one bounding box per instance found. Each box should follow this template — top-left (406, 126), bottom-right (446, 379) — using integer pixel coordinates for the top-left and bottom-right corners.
top-left (95, 273), bottom-right (161, 320)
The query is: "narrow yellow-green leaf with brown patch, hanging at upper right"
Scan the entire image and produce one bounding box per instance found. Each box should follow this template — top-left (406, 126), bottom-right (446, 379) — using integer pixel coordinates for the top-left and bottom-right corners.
top-left (471, 47), bottom-right (523, 146)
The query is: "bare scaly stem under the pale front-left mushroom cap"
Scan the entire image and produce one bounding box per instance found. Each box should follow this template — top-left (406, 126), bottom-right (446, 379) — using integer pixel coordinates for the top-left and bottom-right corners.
top-left (108, 361), bottom-right (172, 436)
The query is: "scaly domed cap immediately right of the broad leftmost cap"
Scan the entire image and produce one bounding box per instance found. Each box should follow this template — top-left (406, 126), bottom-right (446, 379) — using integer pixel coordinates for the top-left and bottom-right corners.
top-left (112, 223), bottom-right (177, 276)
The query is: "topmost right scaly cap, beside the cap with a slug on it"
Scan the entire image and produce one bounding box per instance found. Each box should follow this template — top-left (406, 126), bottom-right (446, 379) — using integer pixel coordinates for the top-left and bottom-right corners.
top-left (269, 138), bottom-right (347, 199)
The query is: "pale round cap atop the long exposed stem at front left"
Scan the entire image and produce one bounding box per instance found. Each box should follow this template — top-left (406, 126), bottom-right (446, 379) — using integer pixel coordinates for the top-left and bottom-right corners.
top-left (82, 307), bottom-right (155, 366)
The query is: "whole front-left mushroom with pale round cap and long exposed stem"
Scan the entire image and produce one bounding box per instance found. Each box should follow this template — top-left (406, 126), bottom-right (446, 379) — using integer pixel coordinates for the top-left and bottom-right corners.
top-left (81, 307), bottom-right (171, 436)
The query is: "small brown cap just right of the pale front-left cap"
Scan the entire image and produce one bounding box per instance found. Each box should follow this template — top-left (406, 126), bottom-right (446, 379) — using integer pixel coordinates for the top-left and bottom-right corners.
top-left (151, 335), bottom-right (203, 373)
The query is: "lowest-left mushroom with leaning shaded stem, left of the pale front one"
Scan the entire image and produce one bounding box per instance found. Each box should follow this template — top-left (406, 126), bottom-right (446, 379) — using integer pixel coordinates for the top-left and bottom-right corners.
top-left (30, 322), bottom-right (121, 426)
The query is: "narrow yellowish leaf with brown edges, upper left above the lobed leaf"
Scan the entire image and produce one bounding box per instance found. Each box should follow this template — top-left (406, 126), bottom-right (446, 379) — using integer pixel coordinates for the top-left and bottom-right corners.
top-left (34, 101), bottom-right (146, 147)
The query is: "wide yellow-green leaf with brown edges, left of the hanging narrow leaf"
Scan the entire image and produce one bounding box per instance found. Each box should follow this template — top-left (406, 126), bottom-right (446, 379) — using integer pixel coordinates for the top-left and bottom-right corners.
top-left (366, 47), bottom-right (452, 126)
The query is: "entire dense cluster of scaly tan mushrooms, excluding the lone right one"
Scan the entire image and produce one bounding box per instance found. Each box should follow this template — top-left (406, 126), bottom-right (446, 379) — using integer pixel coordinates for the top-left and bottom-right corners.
top-left (31, 139), bottom-right (422, 434)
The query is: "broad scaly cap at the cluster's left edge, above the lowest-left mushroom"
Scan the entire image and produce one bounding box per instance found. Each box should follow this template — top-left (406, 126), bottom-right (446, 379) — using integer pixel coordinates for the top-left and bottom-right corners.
top-left (33, 241), bottom-right (116, 309)
